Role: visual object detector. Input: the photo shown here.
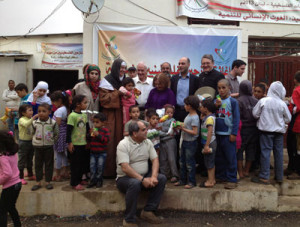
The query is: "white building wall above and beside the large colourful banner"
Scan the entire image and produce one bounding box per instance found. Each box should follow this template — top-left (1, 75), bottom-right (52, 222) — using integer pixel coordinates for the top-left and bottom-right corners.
top-left (83, 0), bottom-right (300, 79)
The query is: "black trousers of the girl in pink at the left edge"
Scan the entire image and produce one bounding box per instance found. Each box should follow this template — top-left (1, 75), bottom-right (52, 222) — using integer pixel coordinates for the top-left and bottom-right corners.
top-left (0, 182), bottom-right (22, 227)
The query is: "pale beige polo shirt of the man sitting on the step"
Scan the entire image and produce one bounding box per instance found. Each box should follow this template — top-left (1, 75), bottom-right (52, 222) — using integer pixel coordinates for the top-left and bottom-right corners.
top-left (117, 136), bottom-right (157, 178)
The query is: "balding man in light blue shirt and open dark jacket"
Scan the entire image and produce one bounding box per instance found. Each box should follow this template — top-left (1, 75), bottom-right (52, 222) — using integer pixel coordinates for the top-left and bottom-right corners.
top-left (171, 57), bottom-right (199, 122)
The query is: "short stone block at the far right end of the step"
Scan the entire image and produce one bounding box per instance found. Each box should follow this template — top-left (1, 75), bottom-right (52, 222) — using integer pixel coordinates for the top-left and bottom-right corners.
top-left (277, 196), bottom-right (300, 212)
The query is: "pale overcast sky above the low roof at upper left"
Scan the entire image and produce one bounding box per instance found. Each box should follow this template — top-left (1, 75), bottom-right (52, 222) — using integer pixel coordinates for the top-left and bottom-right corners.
top-left (0, 0), bottom-right (83, 36)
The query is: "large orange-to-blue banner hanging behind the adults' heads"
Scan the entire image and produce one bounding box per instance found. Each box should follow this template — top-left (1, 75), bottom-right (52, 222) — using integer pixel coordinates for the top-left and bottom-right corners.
top-left (94, 24), bottom-right (241, 76)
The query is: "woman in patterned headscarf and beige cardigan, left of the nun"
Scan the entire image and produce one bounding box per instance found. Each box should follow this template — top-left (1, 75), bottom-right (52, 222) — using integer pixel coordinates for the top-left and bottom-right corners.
top-left (73, 64), bottom-right (101, 128)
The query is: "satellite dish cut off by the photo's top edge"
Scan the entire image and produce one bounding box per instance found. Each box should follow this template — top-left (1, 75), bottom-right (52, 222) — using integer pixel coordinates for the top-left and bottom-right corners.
top-left (72, 0), bottom-right (104, 16)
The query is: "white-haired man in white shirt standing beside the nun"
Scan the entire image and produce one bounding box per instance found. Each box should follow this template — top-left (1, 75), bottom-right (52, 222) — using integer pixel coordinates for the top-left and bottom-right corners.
top-left (133, 62), bottom-right (153, 111)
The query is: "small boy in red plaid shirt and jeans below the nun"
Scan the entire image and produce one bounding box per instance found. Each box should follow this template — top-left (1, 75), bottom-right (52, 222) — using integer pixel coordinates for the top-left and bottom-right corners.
top-left (87, 113), bottom-right (109, 188)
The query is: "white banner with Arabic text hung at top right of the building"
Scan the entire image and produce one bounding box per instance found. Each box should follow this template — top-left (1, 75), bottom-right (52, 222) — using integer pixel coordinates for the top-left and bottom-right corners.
top-left (177, 0), bottom-right (300, 24)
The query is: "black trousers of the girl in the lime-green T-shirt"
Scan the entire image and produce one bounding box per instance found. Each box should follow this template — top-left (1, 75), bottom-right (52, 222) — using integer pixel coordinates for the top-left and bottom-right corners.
top-left (70, 145), bottom-right (86, 186)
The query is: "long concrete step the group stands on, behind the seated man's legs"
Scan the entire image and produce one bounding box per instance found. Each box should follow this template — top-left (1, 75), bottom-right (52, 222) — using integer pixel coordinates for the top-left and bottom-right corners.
top-left (17, 180), bottom-right (278, 216)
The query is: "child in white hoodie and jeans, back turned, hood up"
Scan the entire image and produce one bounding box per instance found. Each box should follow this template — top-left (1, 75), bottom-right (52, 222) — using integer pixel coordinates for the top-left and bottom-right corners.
top-left (251, 81), bottom-right (291, 184)
